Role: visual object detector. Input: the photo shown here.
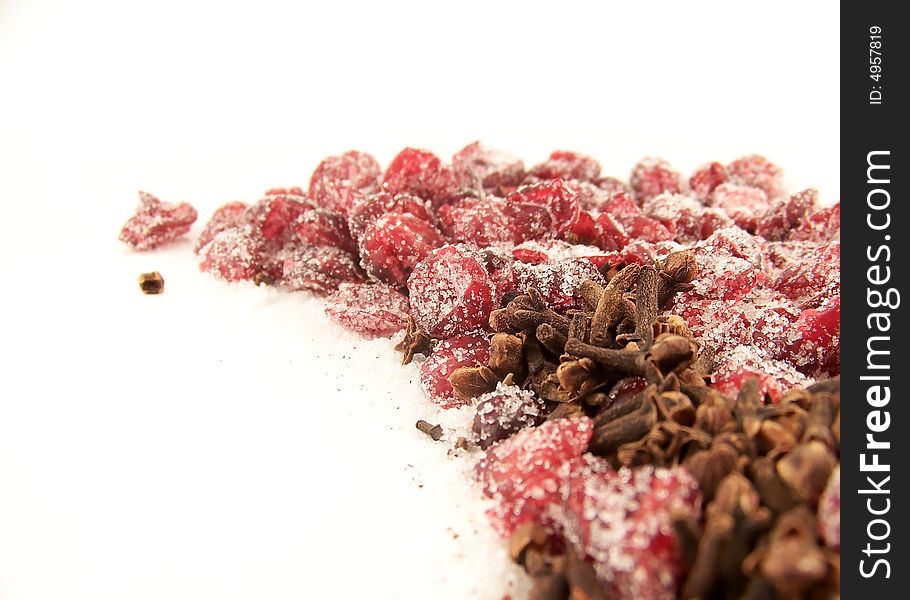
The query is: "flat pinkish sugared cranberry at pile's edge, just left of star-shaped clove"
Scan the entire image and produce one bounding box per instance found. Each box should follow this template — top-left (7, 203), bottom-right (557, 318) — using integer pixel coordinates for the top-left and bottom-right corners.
top-left (325, 283), bottom-right (408, 338)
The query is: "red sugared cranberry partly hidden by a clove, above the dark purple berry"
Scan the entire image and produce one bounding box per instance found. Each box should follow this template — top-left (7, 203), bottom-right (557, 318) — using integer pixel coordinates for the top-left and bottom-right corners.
top-left (418, 333), bottom-right (490, 408)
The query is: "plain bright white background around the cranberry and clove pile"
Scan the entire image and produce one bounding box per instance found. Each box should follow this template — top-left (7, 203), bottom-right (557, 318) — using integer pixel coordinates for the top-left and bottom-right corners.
top-left (0, 0), bottom-right (840, 600)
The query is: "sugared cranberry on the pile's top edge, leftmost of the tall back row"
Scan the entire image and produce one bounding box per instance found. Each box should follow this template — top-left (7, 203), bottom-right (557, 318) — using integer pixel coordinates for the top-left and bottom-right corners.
top-left (309, 150), bottom-right (382, 207)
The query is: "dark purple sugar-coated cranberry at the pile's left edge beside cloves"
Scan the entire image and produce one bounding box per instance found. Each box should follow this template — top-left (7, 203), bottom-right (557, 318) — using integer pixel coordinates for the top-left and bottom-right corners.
top-left (473, 383), bottom-right (547, 450)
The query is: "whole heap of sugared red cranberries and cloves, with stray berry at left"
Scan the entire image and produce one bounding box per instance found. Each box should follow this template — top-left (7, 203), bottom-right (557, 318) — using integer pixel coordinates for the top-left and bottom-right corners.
top-left (121, 143), bottom-right (840, 599)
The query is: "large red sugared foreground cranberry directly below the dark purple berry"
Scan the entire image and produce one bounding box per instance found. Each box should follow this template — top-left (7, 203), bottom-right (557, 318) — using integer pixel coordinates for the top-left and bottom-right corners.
top-left (475, 418), bottom-right (593, 536)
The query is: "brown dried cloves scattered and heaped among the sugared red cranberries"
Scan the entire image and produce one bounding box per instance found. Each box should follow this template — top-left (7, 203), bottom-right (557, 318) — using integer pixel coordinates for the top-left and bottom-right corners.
top-left (400, 251), bottom-right (840, 599)
